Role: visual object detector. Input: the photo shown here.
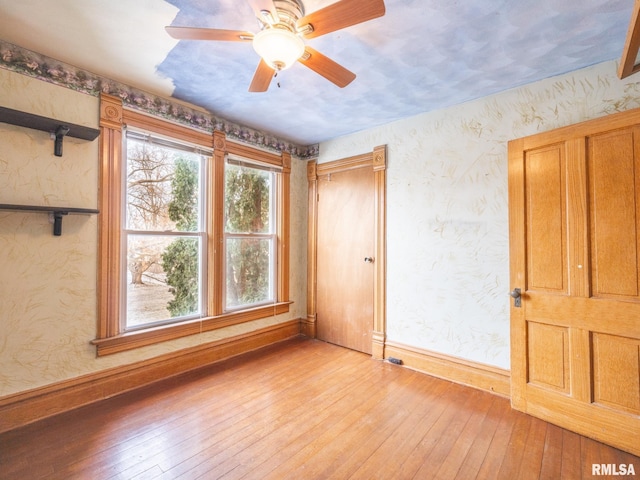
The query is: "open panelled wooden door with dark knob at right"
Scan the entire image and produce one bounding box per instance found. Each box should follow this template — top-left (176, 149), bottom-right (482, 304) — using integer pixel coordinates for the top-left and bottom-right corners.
top-left (509, 111), bottom-right (640, 455)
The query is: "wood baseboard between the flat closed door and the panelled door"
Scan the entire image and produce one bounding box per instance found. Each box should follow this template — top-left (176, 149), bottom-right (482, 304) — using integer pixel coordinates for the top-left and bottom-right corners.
top-left (384, 342), bottom-right (511, 398)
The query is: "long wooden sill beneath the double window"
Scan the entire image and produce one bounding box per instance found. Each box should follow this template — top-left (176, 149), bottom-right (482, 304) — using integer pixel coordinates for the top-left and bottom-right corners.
top-left (91, 302), bottom-right (293, 357)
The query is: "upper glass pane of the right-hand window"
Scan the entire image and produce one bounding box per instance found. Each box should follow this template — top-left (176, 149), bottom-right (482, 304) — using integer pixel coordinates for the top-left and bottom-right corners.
top-left (225, 163), bottom-right (273, 233)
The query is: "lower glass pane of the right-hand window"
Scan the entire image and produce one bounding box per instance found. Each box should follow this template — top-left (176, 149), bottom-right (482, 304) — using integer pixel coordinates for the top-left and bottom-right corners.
top-left (225, 238), bottom-right (273, 309)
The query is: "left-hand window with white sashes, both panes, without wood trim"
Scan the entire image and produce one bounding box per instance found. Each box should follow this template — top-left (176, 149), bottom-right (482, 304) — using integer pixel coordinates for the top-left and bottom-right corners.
top-left (121, 130), bottom-right (212, 331)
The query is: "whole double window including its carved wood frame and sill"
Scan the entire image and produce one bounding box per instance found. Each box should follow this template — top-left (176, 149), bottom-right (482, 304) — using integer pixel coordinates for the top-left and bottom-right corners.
top-left (92, 94), bottom-right (291, 355)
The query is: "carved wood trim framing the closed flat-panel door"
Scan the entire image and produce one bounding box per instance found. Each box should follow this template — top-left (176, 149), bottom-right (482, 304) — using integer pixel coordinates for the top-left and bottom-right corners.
top-left (300, 145), bottom-right (387, 359)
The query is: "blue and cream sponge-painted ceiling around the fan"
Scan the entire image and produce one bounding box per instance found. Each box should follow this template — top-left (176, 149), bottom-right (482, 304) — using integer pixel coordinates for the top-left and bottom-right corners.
top-left (0, 0), bottom-right (633, 145)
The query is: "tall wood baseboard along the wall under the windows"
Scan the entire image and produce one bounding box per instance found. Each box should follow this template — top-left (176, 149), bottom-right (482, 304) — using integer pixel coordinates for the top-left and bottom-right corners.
top-left (0, 319), bottom-right (300, 433)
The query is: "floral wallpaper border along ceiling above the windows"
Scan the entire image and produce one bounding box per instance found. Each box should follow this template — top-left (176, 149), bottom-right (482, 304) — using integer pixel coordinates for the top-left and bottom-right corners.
top-left (0, 40), bottom-right (319, 160)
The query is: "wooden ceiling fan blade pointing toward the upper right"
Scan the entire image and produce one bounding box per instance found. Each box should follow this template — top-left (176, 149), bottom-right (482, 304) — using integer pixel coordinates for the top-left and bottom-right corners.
top-left (298, 0), bottom-right (386, 38)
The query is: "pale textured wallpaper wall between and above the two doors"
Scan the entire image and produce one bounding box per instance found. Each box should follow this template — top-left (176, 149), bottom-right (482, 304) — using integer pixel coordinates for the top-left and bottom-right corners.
top-left (319, 62), bottom-right (640, 369)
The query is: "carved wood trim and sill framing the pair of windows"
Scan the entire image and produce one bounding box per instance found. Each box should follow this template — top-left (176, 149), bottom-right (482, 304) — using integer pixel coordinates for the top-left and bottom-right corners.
top-left (91, 94), bottom-right (292, 356)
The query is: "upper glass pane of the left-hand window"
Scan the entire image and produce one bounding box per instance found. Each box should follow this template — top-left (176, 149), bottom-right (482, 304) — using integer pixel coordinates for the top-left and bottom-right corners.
top-left (127, 138), bottom-right (203, 232)
